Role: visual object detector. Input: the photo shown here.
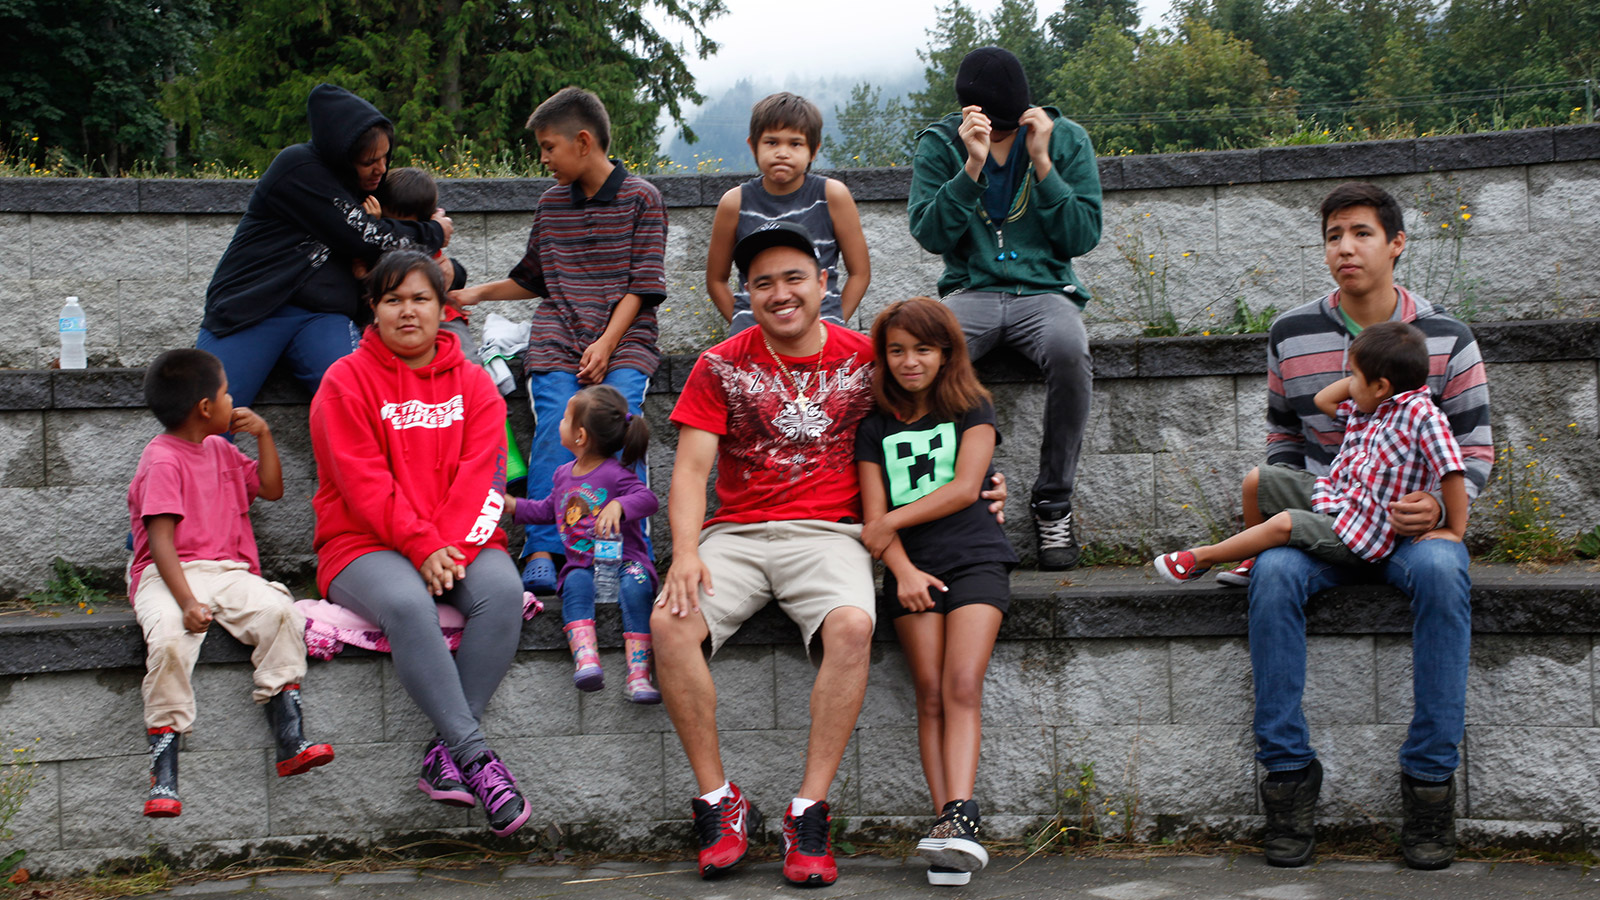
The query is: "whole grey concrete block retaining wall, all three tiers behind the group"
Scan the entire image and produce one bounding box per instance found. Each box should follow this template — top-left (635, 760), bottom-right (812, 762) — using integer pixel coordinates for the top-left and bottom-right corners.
top-left (0, 134), bottom-right (1600, 873)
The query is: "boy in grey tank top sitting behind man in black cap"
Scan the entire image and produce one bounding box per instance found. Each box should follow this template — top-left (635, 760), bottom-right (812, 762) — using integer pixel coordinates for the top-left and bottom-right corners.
top-left (706, 91), bottom-right (872, 335)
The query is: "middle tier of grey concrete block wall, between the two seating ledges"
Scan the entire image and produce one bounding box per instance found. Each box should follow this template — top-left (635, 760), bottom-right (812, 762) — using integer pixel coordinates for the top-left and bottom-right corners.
top-left (0, 319), bottom-right (1600, 594)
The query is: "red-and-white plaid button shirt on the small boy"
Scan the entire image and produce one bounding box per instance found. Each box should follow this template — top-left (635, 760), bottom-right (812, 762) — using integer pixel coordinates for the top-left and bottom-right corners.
top-left (1310, 384), bottom-right (1467, 562)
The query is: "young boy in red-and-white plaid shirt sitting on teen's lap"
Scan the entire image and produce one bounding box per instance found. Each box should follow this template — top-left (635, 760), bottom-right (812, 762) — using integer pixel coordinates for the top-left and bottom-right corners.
top-left (1155, 315), bottom-right (1467, 585)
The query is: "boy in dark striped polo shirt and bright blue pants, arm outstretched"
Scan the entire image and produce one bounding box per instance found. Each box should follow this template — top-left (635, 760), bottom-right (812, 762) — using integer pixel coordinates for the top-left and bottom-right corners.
top-left (451, 88), bottom-right (667, 591)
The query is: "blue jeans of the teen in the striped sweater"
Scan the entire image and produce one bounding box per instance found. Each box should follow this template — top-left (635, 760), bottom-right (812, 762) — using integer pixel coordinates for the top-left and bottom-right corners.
top-left (1250, 538), bottom-right (1472, 781)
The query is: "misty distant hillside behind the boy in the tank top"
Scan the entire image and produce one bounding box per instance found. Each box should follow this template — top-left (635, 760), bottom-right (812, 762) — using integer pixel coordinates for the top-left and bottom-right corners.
top-left (662, 62), bottom-right (923, 171)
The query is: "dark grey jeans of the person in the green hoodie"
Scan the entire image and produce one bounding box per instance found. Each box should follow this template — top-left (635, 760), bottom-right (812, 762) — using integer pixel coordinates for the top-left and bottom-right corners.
top-left (944, 291), bottom-right (1094, 503)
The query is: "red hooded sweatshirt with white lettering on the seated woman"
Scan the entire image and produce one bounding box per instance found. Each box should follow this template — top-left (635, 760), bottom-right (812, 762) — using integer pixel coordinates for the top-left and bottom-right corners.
top-left (310, 318), bottom-right (506, 596)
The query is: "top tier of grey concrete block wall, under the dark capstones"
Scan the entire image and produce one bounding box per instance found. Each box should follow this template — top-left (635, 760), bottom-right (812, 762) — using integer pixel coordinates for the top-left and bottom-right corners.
top-left (0, 125), bottom-right (1600, 368)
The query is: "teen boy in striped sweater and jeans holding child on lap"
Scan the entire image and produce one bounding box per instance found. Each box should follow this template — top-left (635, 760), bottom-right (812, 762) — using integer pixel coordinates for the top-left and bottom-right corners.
top-left (1250, 183), bottom-right (1494, 868)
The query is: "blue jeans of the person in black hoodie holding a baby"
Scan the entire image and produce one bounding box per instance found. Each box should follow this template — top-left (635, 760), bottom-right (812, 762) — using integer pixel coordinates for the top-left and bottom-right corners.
top-left (195, 303), bottom-right (362, 407)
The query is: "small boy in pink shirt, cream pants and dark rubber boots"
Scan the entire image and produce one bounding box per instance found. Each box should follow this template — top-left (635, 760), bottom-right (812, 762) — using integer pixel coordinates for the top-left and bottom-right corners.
top-left (128, 349), bottom-right (333, 818)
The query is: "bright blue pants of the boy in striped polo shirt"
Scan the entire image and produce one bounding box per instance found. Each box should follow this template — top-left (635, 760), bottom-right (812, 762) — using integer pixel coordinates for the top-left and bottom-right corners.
top-left (522, 368), bottom-right (656, 557)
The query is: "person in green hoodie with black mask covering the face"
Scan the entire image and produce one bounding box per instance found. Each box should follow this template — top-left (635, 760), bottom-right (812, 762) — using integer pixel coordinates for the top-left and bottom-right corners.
top-left (909, 46), bottom-right (1101, 569)
